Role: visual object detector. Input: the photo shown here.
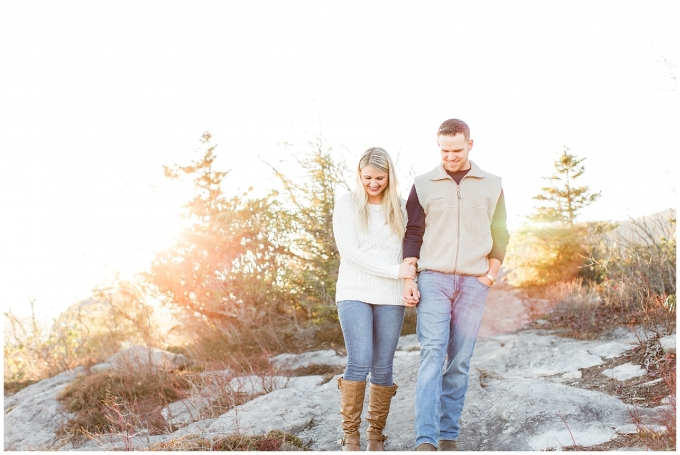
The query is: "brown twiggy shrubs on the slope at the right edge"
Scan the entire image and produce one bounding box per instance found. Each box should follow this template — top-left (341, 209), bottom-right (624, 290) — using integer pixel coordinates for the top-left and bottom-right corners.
top-left (536, 212), bottom-right (676, 338)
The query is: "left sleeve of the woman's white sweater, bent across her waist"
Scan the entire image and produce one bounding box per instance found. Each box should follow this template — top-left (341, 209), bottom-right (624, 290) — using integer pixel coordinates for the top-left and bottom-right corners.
top-left (333, 195), bottom-right (401, 279)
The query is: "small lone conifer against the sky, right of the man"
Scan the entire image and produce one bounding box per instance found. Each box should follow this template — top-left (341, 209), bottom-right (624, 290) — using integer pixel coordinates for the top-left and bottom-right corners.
top-left (531, 146), bottom-right (601, 226)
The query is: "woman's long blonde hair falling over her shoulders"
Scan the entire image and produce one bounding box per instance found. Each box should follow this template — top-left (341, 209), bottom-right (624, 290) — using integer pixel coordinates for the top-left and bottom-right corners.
top-left (351, 147), bottom-right (406, 238)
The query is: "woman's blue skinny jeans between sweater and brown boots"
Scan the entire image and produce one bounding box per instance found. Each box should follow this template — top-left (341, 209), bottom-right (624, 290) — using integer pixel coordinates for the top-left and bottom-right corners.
top-left (338, 300), bottom-right (405, 386)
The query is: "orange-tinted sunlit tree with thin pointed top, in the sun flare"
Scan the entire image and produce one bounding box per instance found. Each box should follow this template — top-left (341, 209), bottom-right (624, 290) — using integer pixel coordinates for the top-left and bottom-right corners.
top-left (148, 132), bottom-right (290, 338)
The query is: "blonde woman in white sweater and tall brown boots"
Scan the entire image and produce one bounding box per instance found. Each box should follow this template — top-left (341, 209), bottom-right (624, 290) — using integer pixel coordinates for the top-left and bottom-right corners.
top-left (333, 147), bottom-right (416, 450)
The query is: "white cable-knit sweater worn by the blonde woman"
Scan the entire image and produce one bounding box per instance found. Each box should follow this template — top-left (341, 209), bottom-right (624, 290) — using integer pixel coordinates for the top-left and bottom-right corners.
top-left (333, 194), bottom-right (406, 305)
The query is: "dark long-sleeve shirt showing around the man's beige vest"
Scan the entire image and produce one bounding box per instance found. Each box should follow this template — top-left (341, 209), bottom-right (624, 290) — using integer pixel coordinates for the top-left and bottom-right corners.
top-left (404, 169), bottom-right (510, 263)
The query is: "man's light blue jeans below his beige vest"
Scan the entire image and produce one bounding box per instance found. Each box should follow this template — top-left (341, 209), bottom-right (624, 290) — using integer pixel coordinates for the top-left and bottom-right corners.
top-left (415, 270), bottom-right (489, 446)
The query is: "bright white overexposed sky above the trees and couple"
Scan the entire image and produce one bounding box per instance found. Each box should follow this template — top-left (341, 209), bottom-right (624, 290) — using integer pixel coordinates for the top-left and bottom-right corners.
top-left (0, 0), bottom-right (680, 317)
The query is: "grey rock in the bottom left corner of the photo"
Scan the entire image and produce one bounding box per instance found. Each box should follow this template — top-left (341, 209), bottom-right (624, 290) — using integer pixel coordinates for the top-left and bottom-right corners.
top-left (4, 367), bottom-right (85, 450)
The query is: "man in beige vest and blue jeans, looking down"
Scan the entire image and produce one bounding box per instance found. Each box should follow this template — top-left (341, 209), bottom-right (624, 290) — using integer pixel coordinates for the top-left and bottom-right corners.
top-left (403, 119), bottom-right (510, 451)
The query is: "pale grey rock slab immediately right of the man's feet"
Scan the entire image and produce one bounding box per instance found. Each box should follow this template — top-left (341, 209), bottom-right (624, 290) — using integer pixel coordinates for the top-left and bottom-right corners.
top-left (460, 370), bottom-right (630, 451)
